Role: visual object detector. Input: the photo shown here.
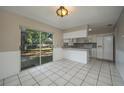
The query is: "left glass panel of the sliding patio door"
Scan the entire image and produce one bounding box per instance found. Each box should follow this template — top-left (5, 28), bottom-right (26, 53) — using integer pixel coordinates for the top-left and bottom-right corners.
top-left (21, 29), bottom-right (40, 70)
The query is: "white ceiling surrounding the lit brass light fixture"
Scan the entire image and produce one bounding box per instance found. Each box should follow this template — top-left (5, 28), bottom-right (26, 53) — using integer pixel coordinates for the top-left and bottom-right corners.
top-left (0, 6), bottom-right (123, 29)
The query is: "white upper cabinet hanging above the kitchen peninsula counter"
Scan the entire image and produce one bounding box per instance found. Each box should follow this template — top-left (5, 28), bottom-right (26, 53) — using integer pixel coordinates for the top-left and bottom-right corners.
top-left (63, 29), bottom-right (87, 39)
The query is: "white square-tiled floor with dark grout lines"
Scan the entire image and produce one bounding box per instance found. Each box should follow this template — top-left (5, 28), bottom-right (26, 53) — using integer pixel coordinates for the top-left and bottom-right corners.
top-left (0, 59), bottom-right (124, 86)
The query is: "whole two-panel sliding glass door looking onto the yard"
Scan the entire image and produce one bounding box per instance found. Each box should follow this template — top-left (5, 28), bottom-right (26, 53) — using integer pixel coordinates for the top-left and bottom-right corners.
top-left (21, 29), bottom-right (53, 70)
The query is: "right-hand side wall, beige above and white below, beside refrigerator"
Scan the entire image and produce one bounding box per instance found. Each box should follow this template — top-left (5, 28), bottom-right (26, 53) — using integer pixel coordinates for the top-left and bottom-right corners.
top-left (115, 10), bottom-right (124, 79)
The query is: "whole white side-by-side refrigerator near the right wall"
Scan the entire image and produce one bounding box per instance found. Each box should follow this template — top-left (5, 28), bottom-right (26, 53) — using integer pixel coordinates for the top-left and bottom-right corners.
top-left (97, 35), bottom-right (113, 61)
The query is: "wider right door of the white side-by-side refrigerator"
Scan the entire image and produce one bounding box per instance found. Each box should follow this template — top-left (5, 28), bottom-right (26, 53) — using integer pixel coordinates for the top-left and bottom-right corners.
top-left (103, 35), bottom-right (113, 60)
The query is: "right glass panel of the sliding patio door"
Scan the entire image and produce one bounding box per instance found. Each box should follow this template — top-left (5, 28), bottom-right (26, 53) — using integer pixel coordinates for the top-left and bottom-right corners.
top-left (41, 32), bottom-right (53, 64)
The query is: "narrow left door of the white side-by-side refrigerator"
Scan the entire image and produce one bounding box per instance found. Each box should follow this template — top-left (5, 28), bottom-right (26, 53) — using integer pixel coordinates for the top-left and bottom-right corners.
top-left (97, 36), bottom-right (103, 59)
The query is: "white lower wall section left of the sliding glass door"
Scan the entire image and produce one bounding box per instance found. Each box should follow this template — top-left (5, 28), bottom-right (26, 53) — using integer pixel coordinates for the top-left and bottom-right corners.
top-left (0, 51), bottom-right (20, 79)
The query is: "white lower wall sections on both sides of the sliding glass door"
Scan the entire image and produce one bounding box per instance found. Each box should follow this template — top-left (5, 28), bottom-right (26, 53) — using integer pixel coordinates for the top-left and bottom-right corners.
top-left (0, 48), bottom-right (63, 80)
